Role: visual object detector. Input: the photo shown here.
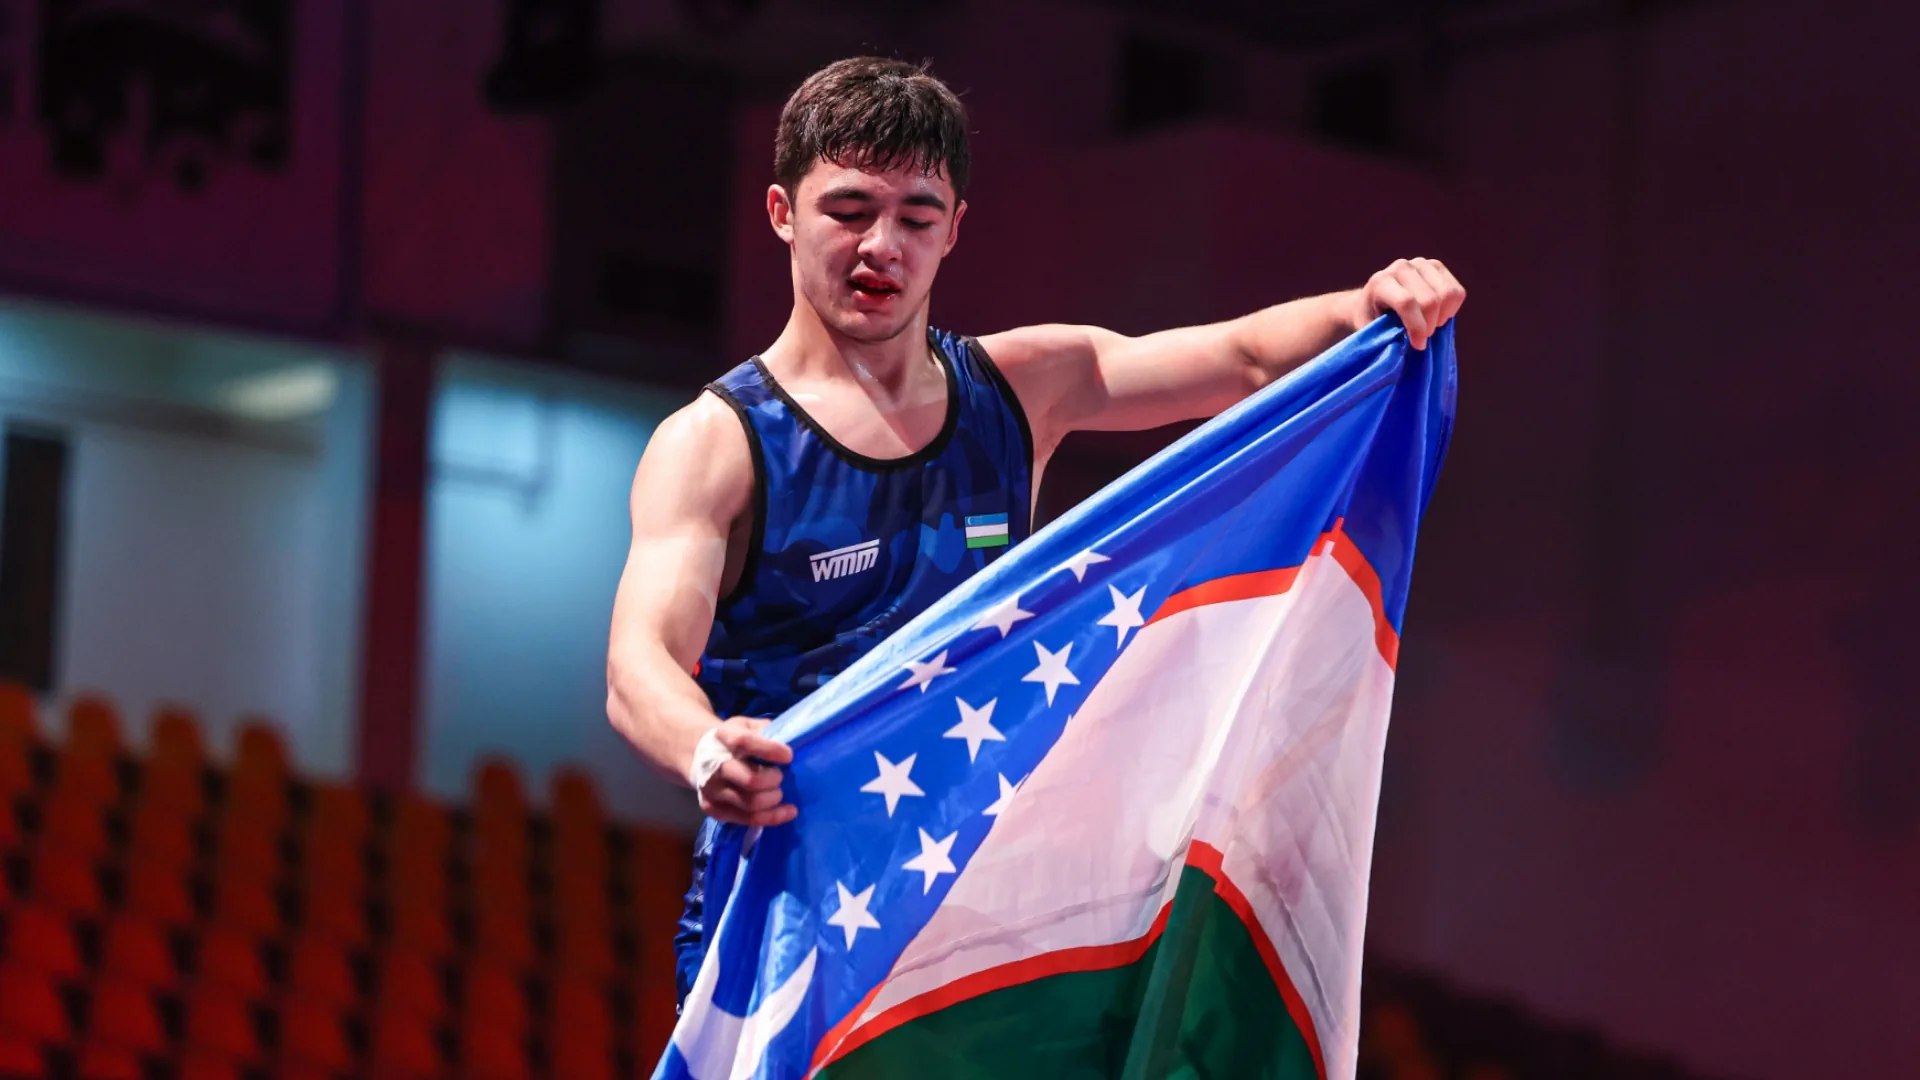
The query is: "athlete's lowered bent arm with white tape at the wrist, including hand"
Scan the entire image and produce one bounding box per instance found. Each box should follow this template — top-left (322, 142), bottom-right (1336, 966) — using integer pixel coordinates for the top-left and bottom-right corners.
top-left (607, 394), bottom-right (795, 824)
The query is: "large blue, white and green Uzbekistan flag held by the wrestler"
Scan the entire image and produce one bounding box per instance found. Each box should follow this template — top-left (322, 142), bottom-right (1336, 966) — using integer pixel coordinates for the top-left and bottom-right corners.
top-left (655, 319), bottom-right (1455, 1080)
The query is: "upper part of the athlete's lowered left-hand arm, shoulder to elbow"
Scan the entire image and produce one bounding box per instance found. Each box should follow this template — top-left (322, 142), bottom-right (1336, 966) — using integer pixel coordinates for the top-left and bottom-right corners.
top-left (612, 396), bottom-right (753, 671)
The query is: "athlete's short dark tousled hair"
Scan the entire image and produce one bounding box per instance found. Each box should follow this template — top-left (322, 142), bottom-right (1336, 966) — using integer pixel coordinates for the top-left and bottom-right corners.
top-left (774, 56), bottom-right (972, 196)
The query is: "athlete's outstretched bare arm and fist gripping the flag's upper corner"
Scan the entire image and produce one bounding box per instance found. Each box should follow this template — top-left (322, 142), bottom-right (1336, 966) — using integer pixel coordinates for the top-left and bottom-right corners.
top-left (981, 259), bottom-right (1467, 443)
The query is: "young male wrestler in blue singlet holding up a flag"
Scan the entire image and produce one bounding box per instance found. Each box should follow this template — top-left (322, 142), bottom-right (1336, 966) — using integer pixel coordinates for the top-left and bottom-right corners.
top-left (607, 58), bottom-right (1465, 995)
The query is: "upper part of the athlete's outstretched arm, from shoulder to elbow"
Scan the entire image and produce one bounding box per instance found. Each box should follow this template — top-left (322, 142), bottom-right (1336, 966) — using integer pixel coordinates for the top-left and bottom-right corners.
top-left (981, 323), bottom-right (1254, 442)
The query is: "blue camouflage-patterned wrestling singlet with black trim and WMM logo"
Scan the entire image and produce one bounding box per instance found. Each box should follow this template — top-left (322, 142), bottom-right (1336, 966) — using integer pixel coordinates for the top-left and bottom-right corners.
top-left (674, 322), bottom-right (1033, 997)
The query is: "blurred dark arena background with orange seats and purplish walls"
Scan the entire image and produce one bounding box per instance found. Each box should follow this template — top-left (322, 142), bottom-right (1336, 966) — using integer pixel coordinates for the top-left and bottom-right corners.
top-left (0, 0), bottom-right (1920, 1080)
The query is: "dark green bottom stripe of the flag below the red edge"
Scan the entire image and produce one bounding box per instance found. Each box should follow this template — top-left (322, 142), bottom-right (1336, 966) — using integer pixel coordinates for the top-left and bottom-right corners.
top-left (820, 867), bottom-right (1315, 1080)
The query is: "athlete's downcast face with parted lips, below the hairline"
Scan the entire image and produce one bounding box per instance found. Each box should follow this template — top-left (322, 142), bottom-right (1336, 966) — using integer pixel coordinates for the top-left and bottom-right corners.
top-left (766, 161), bottom-right (966, 342)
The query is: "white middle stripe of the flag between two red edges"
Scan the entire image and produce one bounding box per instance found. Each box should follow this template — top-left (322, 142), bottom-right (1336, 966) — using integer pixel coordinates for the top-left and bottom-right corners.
top-left (825, 555), bottom-right (1394, 1078)
